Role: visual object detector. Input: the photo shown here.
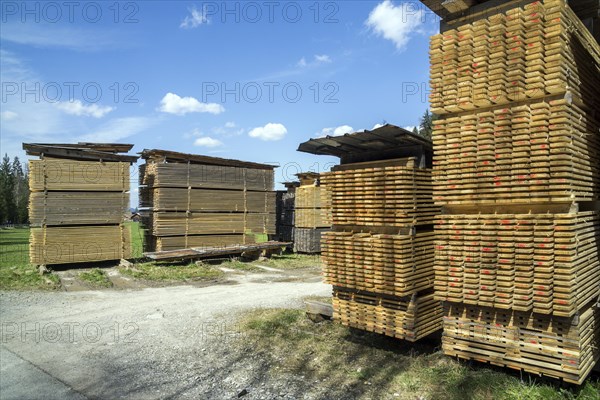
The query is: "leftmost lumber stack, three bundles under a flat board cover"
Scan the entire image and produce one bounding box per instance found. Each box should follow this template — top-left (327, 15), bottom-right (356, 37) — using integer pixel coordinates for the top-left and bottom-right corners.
top-left (23, 143), bottom-right (137, 265)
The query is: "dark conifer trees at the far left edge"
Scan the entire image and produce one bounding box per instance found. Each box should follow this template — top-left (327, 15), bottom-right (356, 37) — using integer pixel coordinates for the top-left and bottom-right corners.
top-left (0, 154), bottom-right (29, 225)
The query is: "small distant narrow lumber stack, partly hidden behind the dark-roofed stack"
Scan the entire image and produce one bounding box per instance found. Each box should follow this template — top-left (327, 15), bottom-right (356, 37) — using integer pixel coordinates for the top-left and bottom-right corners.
top-left (294, 172), bottom-right (331, 254)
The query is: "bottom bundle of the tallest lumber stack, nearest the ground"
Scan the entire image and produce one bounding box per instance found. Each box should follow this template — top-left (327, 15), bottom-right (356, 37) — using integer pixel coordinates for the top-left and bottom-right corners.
top-left (442, 303), bottom-right (600, 384)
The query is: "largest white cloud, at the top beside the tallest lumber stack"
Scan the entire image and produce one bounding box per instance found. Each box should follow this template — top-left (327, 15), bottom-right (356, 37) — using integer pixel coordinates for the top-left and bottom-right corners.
top-left (365, 0), bottom-right (424, 50)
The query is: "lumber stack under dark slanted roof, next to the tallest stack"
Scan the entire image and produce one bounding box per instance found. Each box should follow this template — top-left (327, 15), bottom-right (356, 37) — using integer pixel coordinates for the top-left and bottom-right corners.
top-left (298, 125), bottom-right (442, 341)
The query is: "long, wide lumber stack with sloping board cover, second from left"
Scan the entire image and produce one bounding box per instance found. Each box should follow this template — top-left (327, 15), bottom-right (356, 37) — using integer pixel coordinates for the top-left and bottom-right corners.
top-left (140, 150), bottom-right (275, 252)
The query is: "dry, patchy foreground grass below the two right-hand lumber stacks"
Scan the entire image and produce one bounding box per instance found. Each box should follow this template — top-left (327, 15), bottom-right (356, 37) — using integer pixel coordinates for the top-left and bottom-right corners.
top-left (238, 309), bottom-right (600, 400)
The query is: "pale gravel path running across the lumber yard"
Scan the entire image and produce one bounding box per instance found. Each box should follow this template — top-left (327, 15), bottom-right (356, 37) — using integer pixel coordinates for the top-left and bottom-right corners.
top-left (0, 272), bottom-right (330, 399)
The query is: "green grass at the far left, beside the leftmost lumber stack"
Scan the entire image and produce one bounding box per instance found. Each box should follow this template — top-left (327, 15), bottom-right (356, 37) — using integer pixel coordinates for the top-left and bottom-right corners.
top-left (0, 228), bottom-right (59, 290)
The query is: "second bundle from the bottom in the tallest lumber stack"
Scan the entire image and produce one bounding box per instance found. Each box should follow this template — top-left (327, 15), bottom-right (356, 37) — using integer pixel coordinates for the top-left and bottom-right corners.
top-left (435, 211), bottom-right (600, 317)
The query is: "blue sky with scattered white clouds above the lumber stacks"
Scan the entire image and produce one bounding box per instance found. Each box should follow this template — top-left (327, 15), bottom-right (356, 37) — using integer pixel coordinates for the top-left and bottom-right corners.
top-left (0, 1), bottom-right (438, 206)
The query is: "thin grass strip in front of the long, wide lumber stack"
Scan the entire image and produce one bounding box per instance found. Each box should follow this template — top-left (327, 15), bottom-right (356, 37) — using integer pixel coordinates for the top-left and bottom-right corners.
top-left (119, 262), bottom-right (224, 282)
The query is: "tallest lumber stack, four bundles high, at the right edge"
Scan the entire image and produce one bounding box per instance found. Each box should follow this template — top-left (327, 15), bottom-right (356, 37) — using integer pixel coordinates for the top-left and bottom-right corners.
top-left (430, 0), bottom-right (600, 383)
